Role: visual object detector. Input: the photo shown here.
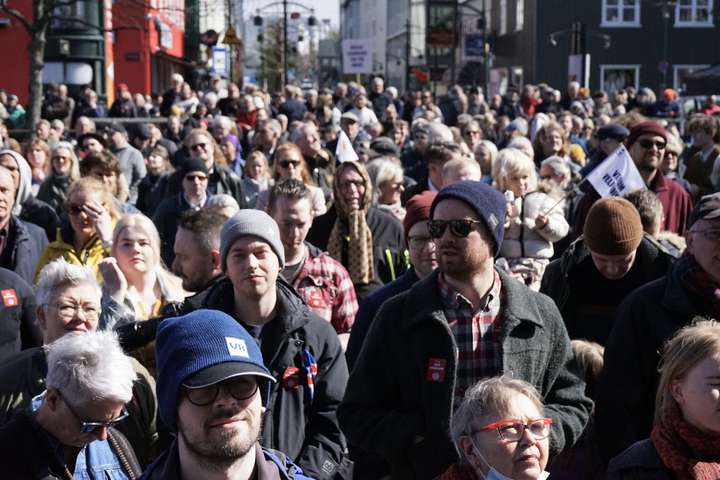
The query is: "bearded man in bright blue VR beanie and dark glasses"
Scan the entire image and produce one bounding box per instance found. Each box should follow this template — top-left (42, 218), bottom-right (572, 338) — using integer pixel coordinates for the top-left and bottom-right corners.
top-left (142, 310), bottom-right (308, 480)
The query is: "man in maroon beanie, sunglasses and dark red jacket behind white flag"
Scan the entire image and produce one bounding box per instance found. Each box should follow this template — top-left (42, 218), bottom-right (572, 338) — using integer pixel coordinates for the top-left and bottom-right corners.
top-left (574, 120), bottom-right (692, 238)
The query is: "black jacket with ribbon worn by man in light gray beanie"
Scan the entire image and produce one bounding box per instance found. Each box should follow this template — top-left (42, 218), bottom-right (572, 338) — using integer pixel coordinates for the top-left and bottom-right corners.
top-left (181, 278), bottom-right (348, 480)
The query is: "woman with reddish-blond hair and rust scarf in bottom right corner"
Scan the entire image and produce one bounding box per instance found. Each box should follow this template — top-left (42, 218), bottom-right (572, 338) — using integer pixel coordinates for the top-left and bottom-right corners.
top-left (607, 321), bottom-right (720, 480)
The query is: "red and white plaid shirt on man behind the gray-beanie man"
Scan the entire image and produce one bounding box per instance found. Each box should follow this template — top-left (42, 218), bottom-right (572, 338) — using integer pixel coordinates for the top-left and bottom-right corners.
top-left (293, 247), bottom-right (358, 334)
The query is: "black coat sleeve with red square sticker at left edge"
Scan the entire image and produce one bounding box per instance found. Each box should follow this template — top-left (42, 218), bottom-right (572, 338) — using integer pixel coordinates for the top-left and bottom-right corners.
top-left (0, 268), bottom-right (42, 361)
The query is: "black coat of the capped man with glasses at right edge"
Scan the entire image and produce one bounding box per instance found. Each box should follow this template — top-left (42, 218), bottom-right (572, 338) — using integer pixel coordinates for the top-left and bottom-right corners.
top-left (595, 263), bottom-right (712, 461)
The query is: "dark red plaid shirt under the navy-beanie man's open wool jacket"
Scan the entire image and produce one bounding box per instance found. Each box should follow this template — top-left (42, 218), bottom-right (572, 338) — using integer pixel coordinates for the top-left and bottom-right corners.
top-left (438, 270), bottom-right (504, 408)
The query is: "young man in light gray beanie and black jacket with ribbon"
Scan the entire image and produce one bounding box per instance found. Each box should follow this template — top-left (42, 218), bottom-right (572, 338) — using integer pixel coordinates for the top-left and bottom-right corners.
top-left (172, 209), bottom-right (348, 480)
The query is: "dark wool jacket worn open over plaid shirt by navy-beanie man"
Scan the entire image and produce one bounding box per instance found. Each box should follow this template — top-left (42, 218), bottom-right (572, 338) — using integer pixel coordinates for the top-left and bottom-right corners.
top-left (338, 272), bottom-right (592, 479)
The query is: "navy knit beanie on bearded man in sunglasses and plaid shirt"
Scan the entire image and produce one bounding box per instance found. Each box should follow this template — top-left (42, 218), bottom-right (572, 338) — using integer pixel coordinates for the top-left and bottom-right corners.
top-left (430, 180), bottom-right (507, 255)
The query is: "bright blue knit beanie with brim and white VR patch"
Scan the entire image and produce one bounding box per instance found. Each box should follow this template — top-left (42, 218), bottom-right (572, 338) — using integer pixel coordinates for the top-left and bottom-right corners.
top-left (155, 310), bottom-right (275, 431)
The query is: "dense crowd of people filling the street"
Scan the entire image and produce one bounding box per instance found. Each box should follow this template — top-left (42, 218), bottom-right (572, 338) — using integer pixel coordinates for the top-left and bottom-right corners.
top-left (0, 74), bottom-right (720, 480)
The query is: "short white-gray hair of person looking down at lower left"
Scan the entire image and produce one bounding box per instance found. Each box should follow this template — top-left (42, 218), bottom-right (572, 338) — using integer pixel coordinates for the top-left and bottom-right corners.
top-left (44, 331), bottom-right (137, 405)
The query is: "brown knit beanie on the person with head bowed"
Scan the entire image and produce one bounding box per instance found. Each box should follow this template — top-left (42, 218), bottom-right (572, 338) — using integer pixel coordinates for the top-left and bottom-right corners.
top-left (583, 197), bottom-right (643, 255)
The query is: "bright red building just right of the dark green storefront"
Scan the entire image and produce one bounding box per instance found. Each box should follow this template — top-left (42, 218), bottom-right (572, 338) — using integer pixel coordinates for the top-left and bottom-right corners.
top-left (112, 0), bottom-right (190, 94)
